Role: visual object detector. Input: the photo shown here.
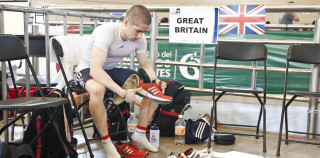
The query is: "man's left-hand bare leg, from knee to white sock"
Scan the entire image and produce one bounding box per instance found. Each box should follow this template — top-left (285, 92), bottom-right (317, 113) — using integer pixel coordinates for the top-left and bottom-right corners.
top-left (86, 79), bottom-right (120, 158)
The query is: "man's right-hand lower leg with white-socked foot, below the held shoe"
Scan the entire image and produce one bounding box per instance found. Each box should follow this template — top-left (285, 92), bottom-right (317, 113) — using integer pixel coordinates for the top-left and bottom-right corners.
top-left (132, 98), bottom-right (158, 152)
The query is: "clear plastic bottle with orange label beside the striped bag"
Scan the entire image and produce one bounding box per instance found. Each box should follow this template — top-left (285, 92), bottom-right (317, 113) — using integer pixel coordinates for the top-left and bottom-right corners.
top-left (174, 115), bottom-right (186, 146)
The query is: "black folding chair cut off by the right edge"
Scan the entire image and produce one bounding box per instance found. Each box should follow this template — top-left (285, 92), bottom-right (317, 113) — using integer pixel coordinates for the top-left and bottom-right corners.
top-left (277, 45), bottom-right (320, 156)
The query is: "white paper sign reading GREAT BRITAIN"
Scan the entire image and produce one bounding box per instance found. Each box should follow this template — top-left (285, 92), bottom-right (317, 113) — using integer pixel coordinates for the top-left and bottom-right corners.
top-left (169, 7), bottom-right (219, 44)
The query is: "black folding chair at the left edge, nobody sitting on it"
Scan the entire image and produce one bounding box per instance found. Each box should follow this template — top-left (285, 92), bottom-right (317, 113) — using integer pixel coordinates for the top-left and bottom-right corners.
top-left (0, 35), bottom-right (68, 157)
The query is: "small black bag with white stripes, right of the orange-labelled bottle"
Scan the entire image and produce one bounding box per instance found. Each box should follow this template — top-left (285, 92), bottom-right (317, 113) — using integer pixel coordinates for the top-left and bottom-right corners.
top-left (185, 119), bottom-right (210, 144)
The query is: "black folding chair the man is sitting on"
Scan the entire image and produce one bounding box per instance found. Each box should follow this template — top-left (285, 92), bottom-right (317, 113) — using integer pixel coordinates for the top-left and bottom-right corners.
top-left (52, 38), bottom-right (132, 157)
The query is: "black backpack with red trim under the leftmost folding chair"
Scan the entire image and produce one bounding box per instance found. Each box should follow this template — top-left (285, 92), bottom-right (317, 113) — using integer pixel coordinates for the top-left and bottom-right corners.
top-left (23, 88), bottom-right (78, 158)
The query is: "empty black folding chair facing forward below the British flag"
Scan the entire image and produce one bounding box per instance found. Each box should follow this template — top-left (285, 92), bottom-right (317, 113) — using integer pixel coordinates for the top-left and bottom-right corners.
top-left (208, 42), bottom-right (267, 152)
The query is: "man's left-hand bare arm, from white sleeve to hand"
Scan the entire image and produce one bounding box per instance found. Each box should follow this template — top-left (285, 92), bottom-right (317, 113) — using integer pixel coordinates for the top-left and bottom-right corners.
top-left (90, 46), bottom-right (141, 106)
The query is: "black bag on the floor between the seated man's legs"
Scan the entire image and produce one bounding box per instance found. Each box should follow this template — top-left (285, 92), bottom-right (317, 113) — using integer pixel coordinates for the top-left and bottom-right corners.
top-left (93, 91), bottom-right (130, 141)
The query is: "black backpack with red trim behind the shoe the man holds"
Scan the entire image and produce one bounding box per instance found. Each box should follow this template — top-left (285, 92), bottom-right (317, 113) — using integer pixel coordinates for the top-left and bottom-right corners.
top-left (151, 79), bottom-right (191, 137)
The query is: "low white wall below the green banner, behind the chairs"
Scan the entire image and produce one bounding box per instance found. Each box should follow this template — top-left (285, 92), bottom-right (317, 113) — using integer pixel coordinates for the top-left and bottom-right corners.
top-left (184, 100), bottom-right (320, 134)
